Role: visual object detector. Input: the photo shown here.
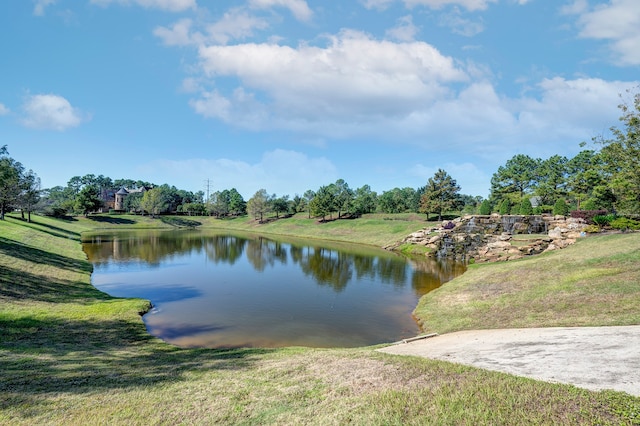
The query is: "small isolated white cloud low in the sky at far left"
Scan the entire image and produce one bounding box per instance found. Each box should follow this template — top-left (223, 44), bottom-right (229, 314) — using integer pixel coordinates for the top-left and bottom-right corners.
top-left (22, 94), bottom-right (83, 131)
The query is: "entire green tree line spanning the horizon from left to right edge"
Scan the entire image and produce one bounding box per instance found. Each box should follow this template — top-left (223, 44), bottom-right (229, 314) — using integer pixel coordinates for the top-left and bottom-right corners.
top-left (0, 88), bottom-right (640, 221)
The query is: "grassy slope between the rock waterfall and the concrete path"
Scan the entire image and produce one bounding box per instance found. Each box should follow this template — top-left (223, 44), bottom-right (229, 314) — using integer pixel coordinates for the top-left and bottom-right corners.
top-left (414, 234), bottom-right (640, 333)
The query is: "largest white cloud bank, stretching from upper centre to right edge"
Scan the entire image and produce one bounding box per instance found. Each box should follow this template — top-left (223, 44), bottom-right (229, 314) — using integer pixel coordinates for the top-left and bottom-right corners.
top-left (186, 26), bottom-right (638, 160)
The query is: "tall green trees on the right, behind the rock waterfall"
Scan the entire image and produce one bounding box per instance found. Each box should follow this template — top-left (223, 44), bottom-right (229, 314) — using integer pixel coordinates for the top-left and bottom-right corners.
top-left (483, 92), bottom-right (640, 215)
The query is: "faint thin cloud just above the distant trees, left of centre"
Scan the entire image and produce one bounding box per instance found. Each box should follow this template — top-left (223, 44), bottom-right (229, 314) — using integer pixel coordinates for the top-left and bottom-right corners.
top-left (139, 149), bottom-right (338, 200)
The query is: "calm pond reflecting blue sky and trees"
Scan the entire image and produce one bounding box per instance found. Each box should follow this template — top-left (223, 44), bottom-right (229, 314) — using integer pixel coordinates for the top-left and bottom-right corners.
top-left (83, 230), bottom-right (465, 348)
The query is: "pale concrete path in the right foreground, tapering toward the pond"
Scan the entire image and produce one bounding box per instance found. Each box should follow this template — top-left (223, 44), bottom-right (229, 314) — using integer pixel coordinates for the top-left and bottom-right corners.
top-left (379, 326), bottom-right (640, 396)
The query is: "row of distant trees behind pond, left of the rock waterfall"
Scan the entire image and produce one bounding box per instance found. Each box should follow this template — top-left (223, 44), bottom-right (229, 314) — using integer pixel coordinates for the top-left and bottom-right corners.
top-left (0, 160), bottom-right (470, 221)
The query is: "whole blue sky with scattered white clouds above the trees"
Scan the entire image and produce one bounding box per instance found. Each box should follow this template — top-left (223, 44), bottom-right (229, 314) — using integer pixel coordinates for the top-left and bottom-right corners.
top-left (0, 0), bottom-right (640, 199)
